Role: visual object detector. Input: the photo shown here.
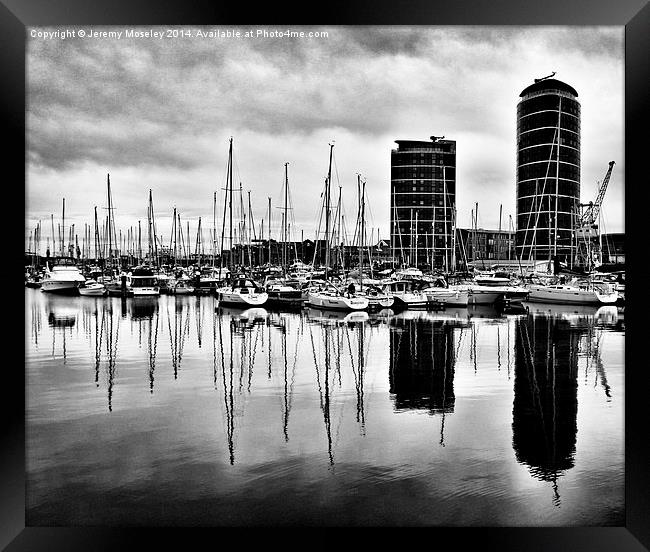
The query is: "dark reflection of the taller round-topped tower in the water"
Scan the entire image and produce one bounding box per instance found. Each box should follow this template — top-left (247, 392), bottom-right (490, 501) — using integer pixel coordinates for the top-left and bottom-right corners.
top-left (512, 313), bottom-right (589, 505)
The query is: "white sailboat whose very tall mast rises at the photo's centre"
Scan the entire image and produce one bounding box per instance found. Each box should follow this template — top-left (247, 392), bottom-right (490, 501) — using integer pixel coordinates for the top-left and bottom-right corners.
top-left (307, 143), bottom-right (368, 311)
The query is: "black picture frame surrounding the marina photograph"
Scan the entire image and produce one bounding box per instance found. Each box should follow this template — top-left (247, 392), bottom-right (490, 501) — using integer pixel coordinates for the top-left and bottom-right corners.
top-left (6, 0), bottom-right (650, 552)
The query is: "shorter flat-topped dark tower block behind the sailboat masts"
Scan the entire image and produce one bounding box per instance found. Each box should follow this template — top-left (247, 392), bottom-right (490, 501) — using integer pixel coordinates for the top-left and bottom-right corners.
top-left (390, 136), bottom-right (456, 270)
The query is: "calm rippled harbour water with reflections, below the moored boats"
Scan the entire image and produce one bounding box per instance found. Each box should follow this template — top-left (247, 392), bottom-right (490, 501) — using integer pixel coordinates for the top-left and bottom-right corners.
top-left (25, 289), bottom-right (625, 526)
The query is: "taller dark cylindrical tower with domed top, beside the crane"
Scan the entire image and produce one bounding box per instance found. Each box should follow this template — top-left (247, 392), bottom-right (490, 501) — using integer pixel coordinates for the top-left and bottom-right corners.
top-left (516, 78), bottom-right (580, 266)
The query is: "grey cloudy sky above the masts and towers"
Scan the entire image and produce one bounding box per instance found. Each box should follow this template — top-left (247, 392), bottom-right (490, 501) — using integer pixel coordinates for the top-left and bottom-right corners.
top-left (26, 26), bottom-right (624, 256)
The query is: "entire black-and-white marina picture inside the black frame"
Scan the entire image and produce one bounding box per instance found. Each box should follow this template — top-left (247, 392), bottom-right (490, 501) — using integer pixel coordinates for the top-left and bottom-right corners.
top-left (23, 22), bottom-right (624, 528)
